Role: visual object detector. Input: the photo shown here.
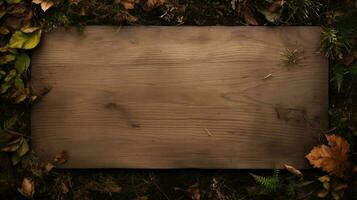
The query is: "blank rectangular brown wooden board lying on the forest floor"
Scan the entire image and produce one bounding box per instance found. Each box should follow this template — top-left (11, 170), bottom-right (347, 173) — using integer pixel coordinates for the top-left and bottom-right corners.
top-left (32, 26), bottom-right (328, 168)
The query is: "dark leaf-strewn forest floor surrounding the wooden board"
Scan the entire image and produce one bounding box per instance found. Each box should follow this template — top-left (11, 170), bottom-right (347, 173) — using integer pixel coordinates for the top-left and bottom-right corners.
top-left (0, 0), bottom-right (357, 200)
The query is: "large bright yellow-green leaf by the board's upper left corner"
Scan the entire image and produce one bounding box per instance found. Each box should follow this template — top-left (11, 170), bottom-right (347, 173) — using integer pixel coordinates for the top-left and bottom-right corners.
top-left (9, 30), bottom-right (41, 49)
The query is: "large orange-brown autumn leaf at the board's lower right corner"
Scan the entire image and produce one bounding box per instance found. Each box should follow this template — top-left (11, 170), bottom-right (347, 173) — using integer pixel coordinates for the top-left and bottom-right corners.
top-left (306, 135), bottom-right (351, 178)
